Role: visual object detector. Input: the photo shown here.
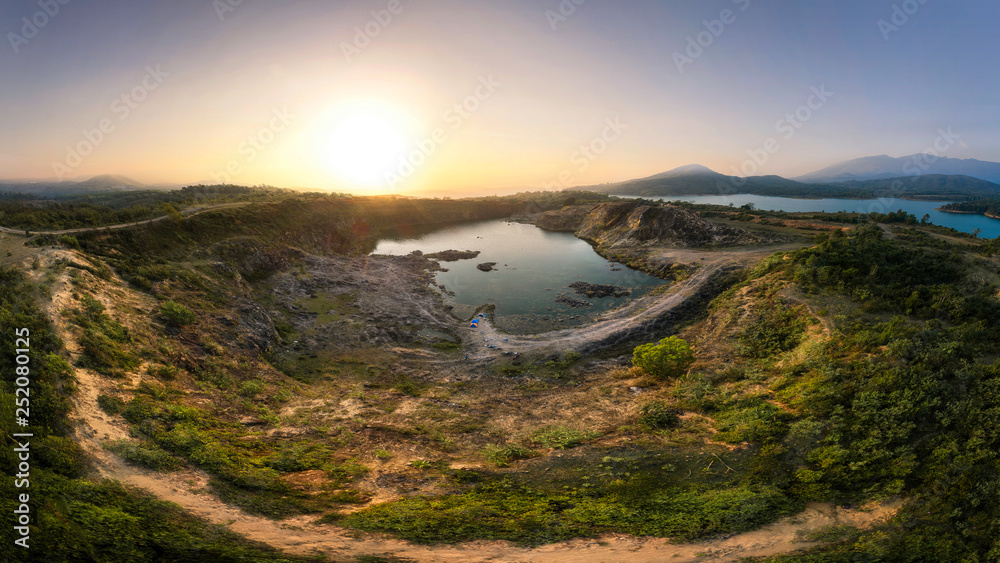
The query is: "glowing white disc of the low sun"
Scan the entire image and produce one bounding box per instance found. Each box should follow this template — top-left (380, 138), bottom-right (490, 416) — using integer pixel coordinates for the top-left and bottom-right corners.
top-left (327, 113), bottom-right (406, 186)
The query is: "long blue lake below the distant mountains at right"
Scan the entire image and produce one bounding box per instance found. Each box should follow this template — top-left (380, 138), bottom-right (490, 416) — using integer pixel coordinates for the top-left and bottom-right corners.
top-left (645, 194), bottom-right (1000, 238)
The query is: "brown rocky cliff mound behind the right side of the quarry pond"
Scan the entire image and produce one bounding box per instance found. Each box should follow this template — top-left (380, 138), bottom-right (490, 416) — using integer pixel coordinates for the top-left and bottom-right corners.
top-left (536, 202), bottom-right (763, 248)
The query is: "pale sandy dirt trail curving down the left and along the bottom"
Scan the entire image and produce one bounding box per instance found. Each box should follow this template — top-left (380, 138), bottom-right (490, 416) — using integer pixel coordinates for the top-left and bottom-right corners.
top-left (41, 242), bottom-right (898, 563)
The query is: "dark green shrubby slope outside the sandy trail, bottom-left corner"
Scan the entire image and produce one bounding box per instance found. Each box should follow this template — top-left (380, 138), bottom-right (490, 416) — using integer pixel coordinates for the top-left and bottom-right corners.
top-left (0, 269), bottom-right (320, 562)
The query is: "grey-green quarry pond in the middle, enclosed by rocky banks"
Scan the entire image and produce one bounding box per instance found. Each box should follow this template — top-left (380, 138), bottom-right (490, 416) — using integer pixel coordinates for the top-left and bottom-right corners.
top-left (372, 221), bottom-right (665, 333)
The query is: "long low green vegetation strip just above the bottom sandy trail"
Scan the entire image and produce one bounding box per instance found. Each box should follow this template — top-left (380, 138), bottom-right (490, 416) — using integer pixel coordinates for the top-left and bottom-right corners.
top-left (341, 480), bottom-right (801, 545)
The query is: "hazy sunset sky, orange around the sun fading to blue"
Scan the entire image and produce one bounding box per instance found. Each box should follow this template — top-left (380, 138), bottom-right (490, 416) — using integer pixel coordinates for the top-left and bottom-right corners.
top-left (0, 0), bottom-right (1000, 194)
